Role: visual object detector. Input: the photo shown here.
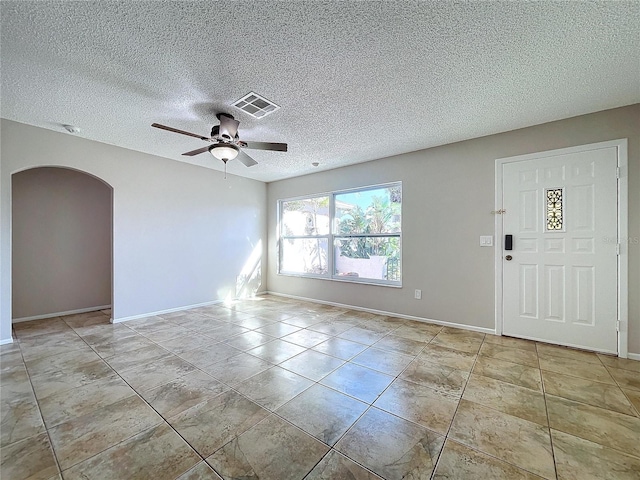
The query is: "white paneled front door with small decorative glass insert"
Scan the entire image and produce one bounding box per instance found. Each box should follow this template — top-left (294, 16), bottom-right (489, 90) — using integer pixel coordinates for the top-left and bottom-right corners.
top-left (502, 147), bottom-right (618, 353)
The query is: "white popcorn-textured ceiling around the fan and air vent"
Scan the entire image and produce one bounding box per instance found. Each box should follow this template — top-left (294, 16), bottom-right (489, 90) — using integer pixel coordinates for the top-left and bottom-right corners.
top-left (0, 0), bottom-right (640, 181)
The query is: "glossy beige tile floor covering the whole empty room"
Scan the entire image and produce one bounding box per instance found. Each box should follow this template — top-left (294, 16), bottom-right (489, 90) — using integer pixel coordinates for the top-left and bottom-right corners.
top-left (0, 296), bottom-right (640, 480)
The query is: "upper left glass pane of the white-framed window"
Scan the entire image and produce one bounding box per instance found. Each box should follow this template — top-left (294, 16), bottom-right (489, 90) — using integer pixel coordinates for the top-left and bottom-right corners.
top-left (281, 197), bottom-right (329, 237)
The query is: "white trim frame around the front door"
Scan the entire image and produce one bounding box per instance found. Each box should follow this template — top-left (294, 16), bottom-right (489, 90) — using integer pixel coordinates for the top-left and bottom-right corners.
top-left (492, 138), bottom-right (629, 358)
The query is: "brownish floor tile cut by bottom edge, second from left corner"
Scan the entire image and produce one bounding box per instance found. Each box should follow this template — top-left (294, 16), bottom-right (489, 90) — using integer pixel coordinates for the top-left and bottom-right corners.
top-left (64, 423), bottom-right (201, 480)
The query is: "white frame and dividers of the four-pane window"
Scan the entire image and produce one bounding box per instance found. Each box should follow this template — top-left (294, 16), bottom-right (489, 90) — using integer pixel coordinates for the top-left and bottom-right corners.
top-left (277, 181), bottom-right (403, 288)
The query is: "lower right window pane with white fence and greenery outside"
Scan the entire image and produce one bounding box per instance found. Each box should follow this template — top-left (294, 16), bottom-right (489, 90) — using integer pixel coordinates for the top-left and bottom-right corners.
top-left (334, 237), bottom-right (401, 282)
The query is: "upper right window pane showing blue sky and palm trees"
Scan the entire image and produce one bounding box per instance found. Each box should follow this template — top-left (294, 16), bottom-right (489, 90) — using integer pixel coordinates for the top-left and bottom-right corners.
top-left (335, 185), bottom-right (402, 235)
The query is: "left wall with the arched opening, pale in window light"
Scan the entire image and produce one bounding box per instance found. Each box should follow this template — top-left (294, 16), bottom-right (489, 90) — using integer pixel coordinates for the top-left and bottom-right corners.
top-left (0, 120), bottom-right (267, 342)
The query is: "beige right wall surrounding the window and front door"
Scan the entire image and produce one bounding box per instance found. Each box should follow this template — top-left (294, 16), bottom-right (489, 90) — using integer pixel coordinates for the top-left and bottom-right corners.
top-left (268, 104), bottom-right (640, 353)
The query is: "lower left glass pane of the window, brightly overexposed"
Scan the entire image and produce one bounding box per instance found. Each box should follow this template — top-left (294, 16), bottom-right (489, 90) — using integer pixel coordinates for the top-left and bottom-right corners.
top-left (280, 238), bottom-right (329, 275)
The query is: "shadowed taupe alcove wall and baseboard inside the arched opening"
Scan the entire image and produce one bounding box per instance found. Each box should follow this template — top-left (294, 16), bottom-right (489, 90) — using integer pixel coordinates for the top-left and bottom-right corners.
top-left (11, 167), bottom-right (113, 322)
